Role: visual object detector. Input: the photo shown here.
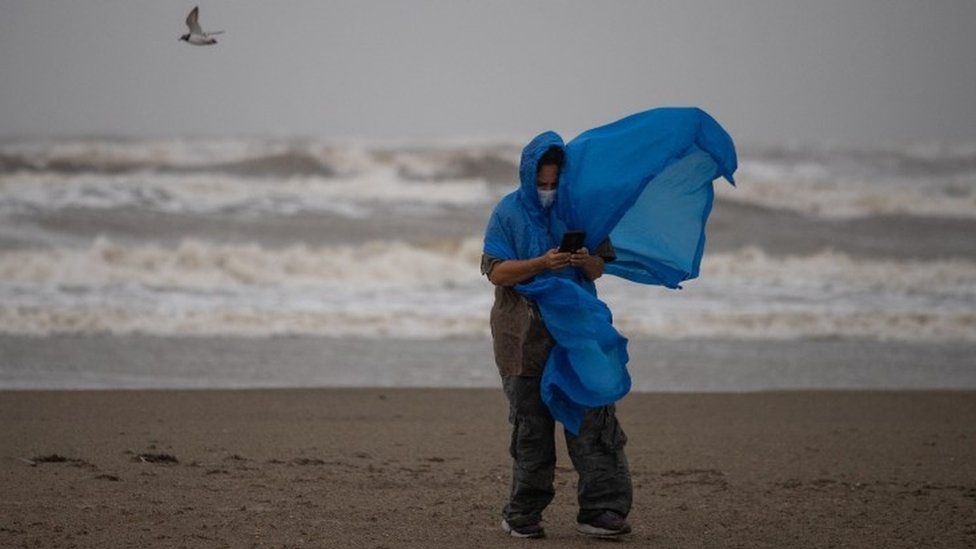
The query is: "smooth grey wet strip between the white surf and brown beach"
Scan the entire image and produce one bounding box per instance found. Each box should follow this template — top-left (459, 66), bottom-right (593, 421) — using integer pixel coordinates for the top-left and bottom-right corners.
top-left (0, 334), bottom-right (976, 392)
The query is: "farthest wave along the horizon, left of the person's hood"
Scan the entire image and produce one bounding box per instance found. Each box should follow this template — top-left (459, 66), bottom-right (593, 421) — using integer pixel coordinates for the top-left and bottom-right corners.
top-left (0, 138), bottom-right (518, 183)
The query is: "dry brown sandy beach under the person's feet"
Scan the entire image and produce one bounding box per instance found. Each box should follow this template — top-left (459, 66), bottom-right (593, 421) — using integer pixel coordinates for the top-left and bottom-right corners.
top-left (0, 389), bottom-right (976, 547)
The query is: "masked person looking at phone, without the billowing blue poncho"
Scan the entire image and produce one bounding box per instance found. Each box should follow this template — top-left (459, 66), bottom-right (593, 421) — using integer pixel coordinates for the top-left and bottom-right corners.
top-left (481, 132), bottom-right (633, 538)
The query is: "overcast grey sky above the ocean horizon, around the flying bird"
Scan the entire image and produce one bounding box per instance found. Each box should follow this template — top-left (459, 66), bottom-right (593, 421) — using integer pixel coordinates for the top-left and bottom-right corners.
top-left (0, 0), bottom-right (976, 146)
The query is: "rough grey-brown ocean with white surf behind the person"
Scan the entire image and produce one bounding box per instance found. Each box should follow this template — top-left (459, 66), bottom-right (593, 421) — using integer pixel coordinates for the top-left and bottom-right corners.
top-left (0, 138), bottom-right (976, 390)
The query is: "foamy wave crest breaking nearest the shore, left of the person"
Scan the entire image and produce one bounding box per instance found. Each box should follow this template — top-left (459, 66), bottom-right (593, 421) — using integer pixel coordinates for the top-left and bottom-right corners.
top-left (0, 238), bottom-right (481, 291)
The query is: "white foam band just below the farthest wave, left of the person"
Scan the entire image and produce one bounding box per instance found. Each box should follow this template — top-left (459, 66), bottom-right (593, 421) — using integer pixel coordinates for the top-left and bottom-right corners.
top-left (0, 169), bottom-right (495, 217)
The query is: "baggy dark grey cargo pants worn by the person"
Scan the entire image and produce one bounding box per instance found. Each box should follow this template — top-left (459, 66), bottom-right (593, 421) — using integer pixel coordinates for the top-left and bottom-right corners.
top-left (502, 376), bottom-right (633, 526)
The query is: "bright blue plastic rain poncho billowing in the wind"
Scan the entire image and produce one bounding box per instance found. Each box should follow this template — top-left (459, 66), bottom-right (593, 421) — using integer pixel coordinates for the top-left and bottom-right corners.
top-left (484, 108), bottom-right (737, 434)
